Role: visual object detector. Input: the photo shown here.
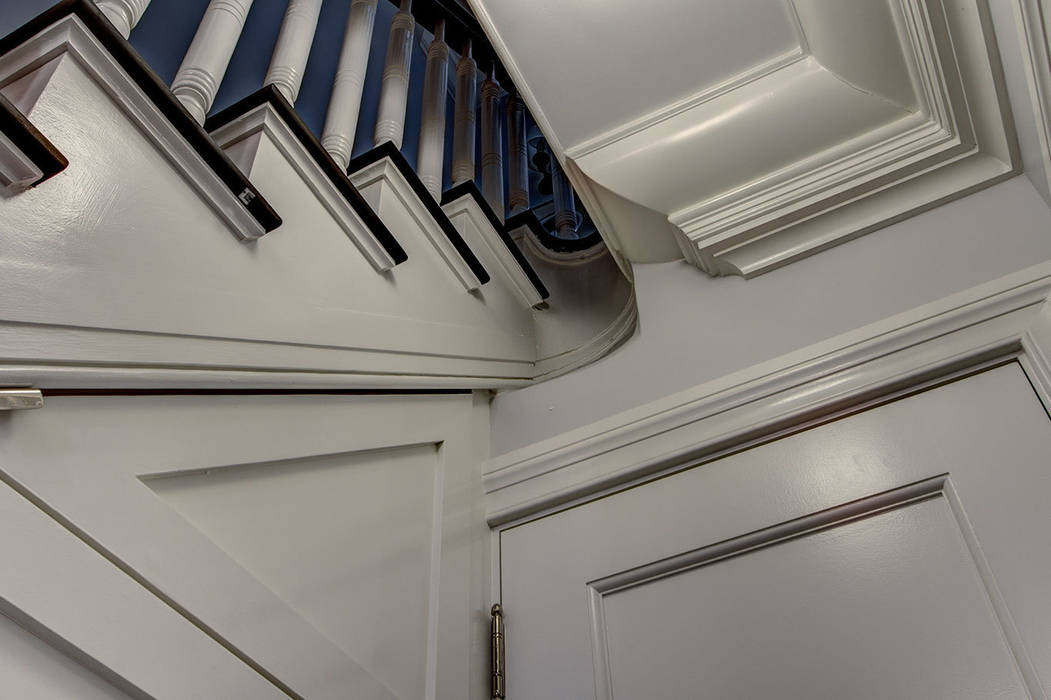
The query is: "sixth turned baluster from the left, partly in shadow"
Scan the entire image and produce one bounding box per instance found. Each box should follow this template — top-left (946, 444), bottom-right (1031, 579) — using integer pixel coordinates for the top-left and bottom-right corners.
top-left (416, 20), bottom-right (449, 200)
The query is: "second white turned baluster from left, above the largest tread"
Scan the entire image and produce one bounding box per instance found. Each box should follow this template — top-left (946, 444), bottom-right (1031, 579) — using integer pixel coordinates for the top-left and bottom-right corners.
top-left (171, 0), bottom-right (252, 124)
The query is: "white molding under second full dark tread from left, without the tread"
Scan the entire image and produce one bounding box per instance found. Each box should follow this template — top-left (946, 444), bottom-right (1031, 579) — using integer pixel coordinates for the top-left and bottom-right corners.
top-left (211, 103), bottom-right (395, 272)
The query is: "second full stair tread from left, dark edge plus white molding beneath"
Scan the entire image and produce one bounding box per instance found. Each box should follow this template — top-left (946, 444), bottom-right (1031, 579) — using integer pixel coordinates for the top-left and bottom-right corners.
top-left (205, 85), bottom-right (408, 272)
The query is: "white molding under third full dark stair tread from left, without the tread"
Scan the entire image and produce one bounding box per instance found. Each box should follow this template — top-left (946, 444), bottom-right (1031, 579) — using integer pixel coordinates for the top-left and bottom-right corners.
top-left (350, 157), bottom-right (481, 291)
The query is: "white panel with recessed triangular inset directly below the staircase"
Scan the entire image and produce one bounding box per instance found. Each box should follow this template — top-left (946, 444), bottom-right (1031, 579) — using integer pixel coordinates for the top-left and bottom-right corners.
top-left (0, 395), bottom-right (488, 700)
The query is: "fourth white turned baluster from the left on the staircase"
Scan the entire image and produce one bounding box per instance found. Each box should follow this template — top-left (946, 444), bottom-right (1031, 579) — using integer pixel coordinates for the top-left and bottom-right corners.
top-left (322, 0), bottom-right (376, 169)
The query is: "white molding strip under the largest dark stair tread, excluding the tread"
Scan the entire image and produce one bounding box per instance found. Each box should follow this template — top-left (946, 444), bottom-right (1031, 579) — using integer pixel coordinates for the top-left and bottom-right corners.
top-left (0, 15), bottom-right (266, 240)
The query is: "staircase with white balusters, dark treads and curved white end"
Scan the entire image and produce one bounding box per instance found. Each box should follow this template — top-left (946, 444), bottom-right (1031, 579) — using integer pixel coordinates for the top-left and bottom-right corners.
top-left (0, 0), bottom-right (635, 390)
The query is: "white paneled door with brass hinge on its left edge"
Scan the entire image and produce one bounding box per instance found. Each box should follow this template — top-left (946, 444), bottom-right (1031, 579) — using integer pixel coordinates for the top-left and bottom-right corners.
top-left (499, 363), bottom-right (1051, 699)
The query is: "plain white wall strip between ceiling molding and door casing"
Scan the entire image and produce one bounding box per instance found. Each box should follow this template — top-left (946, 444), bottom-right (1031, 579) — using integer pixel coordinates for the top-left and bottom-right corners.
top-left (492, 178), bottom-right (1051, 455)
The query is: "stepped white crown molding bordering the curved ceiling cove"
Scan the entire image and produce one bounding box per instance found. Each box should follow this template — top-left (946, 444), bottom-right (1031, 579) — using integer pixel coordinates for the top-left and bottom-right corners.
top-left (668, 0), bottom-right (1017, 277)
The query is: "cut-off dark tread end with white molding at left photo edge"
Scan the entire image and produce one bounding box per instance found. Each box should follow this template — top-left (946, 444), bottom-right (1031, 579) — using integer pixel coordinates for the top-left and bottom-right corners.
top-left (0, 89), bottom-right (69, 197)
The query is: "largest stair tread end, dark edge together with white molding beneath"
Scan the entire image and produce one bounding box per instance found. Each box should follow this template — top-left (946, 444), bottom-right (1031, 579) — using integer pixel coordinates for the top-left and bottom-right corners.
top-left (0, 0), bottom-right (281, 241)
